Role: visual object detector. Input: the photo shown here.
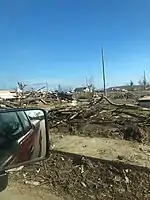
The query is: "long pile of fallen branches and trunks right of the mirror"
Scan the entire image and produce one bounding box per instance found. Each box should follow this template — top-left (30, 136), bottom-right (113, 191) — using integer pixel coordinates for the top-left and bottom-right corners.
top-left (48, 96), bottom-right (150, 142)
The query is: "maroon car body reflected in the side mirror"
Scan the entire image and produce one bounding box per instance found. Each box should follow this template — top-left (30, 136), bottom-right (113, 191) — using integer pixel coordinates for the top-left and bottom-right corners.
top-left (0, 111), bottom-right (42, 167)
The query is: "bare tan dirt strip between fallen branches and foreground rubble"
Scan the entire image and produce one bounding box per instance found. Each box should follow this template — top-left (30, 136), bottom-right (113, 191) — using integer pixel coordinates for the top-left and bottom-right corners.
top-left (53, 135), bottom-right (150, 167)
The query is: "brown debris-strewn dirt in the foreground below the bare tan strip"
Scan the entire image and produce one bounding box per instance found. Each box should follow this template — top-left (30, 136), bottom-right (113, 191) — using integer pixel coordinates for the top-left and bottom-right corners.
top-left (10, 151), bottom-right (150, 200)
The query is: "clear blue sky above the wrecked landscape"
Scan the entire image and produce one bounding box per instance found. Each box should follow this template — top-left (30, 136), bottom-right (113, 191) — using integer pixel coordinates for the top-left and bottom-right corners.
top-left (0, 0), bottom-right (150, 88)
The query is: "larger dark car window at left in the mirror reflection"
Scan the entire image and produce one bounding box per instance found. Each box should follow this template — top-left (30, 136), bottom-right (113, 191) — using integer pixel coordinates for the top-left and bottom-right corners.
top-left (0, 112), bottom-right (23, 140)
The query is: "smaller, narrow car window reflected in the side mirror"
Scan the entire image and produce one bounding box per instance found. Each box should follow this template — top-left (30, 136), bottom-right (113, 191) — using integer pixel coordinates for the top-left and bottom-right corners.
top-left (17, 111), bottom-right (31, 134)
